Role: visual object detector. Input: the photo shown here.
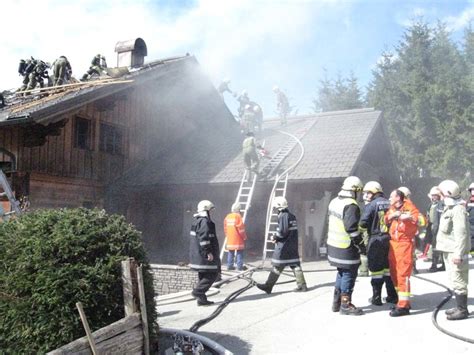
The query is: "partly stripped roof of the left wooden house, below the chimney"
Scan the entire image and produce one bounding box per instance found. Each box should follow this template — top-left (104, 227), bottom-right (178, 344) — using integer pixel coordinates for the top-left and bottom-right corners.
top-left (0, 55), bottom-right (197, 125)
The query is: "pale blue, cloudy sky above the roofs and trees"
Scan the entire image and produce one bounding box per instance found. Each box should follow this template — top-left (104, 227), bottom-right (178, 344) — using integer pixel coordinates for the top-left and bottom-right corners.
top-left (0, 0), bottom-right (474, 117)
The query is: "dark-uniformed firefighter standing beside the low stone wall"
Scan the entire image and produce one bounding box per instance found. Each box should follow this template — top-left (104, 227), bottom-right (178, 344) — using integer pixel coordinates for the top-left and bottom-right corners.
top-left (189, 200), bottom-right (220, 306)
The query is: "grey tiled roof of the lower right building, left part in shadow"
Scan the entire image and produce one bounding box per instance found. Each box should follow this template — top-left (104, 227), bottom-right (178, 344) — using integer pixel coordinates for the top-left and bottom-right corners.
top-left (126, 109), bottom-right (381, 186)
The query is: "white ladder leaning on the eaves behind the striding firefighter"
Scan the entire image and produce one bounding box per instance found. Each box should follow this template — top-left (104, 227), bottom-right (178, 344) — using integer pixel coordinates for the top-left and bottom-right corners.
top-left (262, 173), bottom-right (288, 265)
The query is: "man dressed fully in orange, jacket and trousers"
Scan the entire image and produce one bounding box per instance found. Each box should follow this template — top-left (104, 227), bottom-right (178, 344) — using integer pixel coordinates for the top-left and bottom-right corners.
top-left (385, 190), bottom-right (419, 317)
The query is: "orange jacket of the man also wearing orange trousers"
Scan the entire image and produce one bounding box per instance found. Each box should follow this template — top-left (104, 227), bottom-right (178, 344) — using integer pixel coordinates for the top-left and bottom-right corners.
top-left (384, 200), bottom-right (420, 241)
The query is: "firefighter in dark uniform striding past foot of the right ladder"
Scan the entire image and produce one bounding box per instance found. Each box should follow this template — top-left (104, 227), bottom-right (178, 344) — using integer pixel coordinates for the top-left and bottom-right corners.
top-left (257, 196), bottom-right (308, 294)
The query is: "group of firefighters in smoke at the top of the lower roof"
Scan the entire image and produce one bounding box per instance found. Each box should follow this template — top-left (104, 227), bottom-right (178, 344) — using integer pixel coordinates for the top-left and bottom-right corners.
top-left (217, 79), bottom-right (291, 133)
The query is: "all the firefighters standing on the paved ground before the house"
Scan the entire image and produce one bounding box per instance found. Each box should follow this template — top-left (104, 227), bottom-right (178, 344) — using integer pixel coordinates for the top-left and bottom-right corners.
top-left (190, 176), bottom-right (474, 320)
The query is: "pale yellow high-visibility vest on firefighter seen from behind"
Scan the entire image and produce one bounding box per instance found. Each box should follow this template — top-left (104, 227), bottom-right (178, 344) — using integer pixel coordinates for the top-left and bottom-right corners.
top-left (327, 197), bottom-right (357, 249)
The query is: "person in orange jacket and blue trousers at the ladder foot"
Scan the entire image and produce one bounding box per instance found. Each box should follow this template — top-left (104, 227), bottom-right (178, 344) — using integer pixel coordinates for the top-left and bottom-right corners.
top-left (224, 202), bottom-right (247, 271)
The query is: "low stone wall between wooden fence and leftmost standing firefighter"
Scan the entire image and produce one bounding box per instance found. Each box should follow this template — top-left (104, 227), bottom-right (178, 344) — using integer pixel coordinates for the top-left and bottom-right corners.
top-left (150, 264), bottom-right (198, 296)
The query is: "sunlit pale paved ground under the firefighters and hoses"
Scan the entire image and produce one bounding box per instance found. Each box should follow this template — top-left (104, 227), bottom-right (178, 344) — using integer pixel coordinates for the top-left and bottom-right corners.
top-left (158, 259), bottom-right (474, 355)
